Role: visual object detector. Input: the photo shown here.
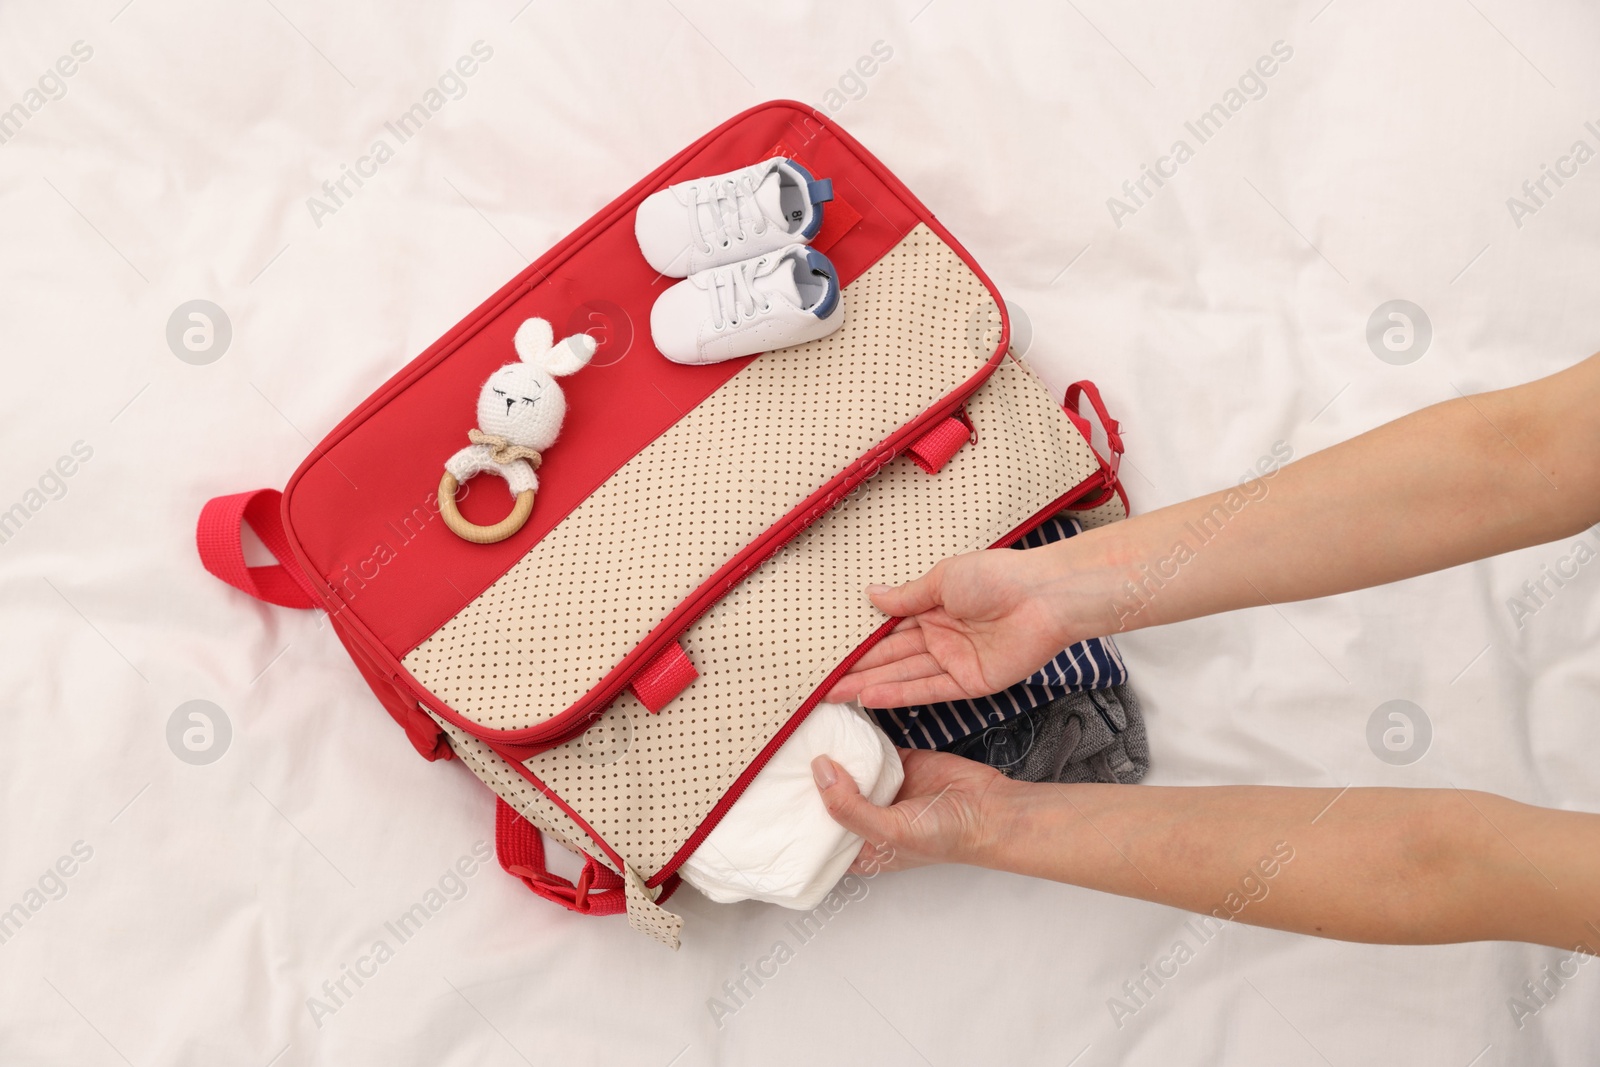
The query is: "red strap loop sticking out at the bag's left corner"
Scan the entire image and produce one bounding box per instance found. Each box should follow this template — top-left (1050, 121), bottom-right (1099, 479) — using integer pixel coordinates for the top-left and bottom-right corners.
top-left (195, 490), bottom-right (318, 608)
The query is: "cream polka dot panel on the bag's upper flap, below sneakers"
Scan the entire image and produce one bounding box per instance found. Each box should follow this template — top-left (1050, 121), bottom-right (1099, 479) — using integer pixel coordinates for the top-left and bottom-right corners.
top-left (403, 224), bottom-right (1000, 729)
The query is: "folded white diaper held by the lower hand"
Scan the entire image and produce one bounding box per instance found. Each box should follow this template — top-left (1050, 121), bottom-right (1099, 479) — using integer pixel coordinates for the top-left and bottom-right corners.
top-left (678, 704), bottom-right (906, 912)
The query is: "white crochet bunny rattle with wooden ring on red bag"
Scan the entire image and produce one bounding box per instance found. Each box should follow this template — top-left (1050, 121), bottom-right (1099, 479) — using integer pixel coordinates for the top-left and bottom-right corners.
top-left (438, 310), bottom-right (595, 544)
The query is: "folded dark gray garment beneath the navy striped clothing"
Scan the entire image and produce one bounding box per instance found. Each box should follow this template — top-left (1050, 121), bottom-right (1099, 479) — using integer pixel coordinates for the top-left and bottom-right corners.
top-left (949, 683), bottom-right (1150, 784)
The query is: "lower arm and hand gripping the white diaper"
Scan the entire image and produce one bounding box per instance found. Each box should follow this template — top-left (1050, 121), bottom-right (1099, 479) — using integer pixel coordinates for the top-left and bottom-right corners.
top-left (813, 752), bottom-right (1600, 953)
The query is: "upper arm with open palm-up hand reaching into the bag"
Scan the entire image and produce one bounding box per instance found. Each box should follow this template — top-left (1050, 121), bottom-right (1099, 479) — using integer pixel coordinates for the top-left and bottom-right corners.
top-left (829, 357), bottom-right (1600, 707)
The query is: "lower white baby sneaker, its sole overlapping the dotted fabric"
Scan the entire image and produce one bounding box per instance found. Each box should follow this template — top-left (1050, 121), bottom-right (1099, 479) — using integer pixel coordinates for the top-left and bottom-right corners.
top-left (650, 245), bottom-right (845, 363)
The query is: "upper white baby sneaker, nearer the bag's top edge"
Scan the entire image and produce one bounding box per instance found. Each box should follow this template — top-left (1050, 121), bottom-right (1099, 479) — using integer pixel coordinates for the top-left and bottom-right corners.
top-left (634, 155), bottom-right (834, 278)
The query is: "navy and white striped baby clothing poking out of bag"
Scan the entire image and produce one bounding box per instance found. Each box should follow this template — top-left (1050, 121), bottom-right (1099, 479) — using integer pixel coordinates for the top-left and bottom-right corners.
top-left (869, 514), bottom-right (1128, 749)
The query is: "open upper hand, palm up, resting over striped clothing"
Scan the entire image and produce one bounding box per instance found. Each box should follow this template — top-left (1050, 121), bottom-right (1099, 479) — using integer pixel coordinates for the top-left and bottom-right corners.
top-left (827, 545), bottom-right (1080, 707)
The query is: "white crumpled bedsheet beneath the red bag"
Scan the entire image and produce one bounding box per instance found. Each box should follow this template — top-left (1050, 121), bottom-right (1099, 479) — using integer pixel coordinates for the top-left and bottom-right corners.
top-left (0, 0), bottom-right (1600, 1067)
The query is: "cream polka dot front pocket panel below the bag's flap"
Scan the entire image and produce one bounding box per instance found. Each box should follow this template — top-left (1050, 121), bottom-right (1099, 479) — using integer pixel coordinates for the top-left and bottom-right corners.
top-left (526, 360), bottom-right (1099, 875)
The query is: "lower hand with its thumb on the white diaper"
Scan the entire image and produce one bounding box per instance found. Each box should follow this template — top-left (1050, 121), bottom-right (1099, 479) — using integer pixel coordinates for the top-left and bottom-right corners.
top-left (811, 749), bottom-right (1010, 875)
